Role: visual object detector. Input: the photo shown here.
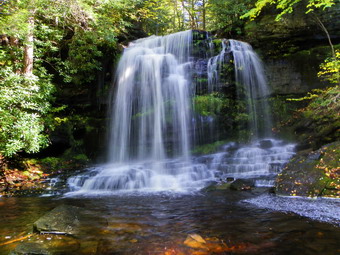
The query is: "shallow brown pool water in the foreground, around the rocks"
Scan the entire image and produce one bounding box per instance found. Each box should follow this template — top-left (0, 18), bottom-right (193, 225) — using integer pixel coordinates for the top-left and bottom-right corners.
top-left (0, 191), bottom-right (340, 254)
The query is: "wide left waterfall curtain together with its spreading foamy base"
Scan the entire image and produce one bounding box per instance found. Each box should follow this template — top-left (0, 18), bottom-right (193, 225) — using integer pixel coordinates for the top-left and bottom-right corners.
top-left (69, 31), bottom-right (214, 193)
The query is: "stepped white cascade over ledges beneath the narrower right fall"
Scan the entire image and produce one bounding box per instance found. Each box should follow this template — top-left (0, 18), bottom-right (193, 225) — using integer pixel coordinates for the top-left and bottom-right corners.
top-left (197, 139), bottom-right (295, 187)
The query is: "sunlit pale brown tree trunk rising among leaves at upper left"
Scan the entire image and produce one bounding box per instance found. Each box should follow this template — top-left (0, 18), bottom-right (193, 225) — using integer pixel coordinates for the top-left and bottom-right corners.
top-left (23, 15), bottom-right (34, 76)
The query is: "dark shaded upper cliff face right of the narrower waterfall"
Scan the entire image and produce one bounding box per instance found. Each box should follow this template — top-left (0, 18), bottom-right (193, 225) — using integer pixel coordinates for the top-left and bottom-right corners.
top-left (244, 4), bottom-right (340, 95)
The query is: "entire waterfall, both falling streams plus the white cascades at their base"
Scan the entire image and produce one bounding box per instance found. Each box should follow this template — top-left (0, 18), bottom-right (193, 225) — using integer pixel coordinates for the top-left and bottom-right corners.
top-left (68, 31), bottom-right (293, 195)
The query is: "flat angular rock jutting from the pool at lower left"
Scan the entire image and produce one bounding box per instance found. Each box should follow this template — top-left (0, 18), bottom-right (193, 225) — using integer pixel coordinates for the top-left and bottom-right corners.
top-left (33, 205), bottom-right (85, 235)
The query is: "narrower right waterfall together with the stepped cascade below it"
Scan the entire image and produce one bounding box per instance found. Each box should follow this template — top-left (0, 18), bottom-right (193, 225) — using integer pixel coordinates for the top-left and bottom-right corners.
top-left (201, 40), bottom-right (295, 182)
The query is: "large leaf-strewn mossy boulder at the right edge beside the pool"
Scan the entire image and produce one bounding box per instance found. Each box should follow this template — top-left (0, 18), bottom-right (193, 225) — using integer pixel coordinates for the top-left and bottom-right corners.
top-left (275, 142), bottom-right (340, 198)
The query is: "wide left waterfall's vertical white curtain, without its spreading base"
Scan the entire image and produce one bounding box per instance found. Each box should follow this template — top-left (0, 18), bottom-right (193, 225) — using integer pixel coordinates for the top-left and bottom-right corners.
top-left (109, 31), bottom-right (192, 162)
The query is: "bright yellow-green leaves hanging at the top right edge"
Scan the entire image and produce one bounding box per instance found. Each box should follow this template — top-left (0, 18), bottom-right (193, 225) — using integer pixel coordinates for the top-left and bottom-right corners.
top-left (241, 0), bottom-right (336, 21)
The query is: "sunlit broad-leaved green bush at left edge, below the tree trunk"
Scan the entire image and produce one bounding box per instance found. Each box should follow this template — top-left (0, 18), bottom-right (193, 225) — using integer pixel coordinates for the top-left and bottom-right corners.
top-left (0, 68), bottom-right (53, 156)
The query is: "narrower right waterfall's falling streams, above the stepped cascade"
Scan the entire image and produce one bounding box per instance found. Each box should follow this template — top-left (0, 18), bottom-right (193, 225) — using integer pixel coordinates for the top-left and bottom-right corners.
top-left (207, 39), bottom-right (272, 140)
